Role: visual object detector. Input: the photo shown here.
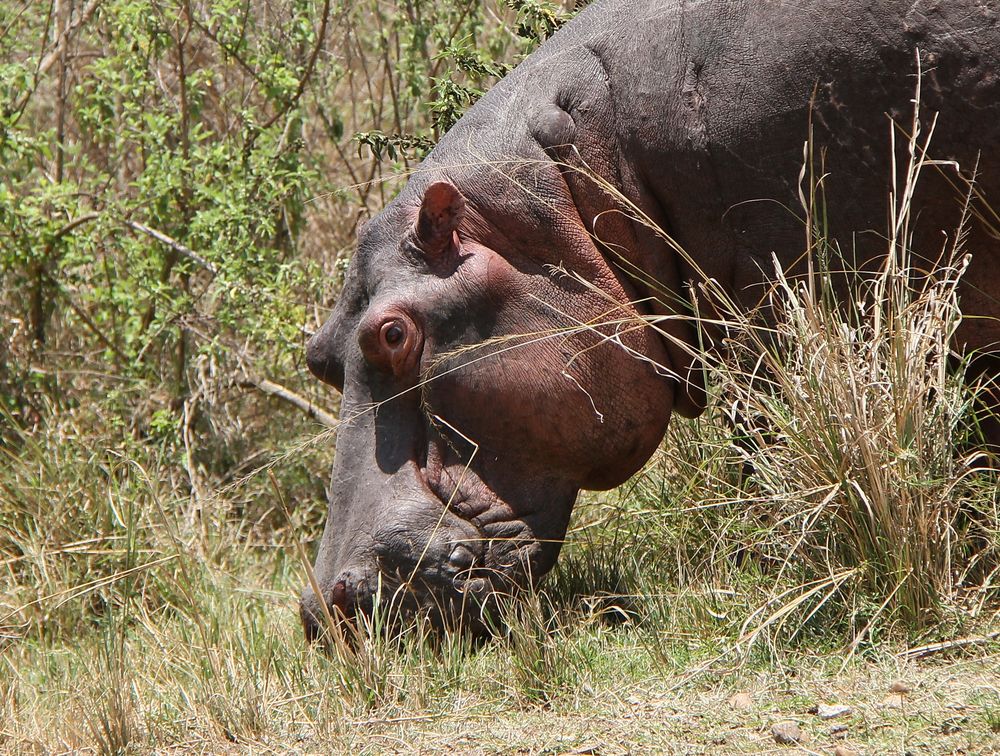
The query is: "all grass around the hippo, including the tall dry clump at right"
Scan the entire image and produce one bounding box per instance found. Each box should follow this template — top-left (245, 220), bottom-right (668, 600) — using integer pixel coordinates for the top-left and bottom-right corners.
top-left (0, 41), bottom-right (1000, 753)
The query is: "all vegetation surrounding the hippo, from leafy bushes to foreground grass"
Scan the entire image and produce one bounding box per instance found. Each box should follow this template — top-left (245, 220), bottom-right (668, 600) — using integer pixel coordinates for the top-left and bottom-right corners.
top-left (0, 0), bottom-right (1000, 753)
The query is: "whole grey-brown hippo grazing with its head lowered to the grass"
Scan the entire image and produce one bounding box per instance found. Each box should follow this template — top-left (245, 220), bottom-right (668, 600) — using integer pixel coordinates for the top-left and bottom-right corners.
top-left (301, 0), bottom-right (1000, 638)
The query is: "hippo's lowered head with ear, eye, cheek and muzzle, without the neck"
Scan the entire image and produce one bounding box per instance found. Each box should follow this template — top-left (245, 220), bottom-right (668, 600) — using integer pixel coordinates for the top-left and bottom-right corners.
top-left (301, 170), bottom-right (688, 639)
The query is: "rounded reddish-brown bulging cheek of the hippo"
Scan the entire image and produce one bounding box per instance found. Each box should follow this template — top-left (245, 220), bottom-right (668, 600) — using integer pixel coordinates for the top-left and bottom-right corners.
top-left (425, 318), bottom-right (673, 489)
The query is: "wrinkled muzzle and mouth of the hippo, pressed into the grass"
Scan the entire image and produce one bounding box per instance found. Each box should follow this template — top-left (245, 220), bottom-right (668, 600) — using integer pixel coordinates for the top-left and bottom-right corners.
top-left (300, 410), bottom-right (576, 641)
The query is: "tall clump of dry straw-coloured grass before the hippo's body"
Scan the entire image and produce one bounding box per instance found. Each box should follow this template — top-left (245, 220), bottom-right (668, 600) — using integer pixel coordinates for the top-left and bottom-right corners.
top-left (548, 82), bottom-right (1000, 648)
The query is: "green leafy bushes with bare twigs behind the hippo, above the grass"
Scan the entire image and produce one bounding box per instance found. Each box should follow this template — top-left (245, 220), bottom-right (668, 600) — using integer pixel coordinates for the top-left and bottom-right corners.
top-left (0, 0), bottom-right (531, 484)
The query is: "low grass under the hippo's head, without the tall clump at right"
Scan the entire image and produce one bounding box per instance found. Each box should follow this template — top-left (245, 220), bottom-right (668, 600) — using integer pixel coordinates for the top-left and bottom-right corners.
top-left (0, 404), bottom-right (1000, 753)
